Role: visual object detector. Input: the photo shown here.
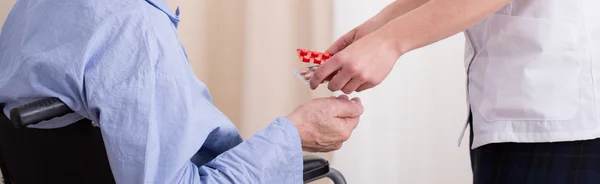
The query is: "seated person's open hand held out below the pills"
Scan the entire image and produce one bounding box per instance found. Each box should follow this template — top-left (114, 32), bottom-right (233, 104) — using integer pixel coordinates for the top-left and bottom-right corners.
top-left (287, 95), bottom-right (363, 152)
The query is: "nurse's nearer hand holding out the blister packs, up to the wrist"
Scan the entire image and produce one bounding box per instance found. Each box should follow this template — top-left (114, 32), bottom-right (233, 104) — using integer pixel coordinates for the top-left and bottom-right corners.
top-left (310, 29), bottom-right (402, 94)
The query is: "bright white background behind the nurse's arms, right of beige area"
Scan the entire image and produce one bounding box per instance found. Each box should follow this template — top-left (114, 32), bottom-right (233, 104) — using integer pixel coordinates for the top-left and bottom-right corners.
top-left (332, 0), bottom-right (471, 184)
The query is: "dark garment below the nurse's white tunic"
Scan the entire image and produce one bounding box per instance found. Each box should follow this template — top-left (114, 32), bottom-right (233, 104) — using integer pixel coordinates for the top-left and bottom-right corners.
top-left (471, 118), bottom-right (600, 184)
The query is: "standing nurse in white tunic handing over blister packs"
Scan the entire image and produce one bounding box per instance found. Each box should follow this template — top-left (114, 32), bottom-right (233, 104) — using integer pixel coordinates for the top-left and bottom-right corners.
top-left (310, 0), bottom-right (600, 184)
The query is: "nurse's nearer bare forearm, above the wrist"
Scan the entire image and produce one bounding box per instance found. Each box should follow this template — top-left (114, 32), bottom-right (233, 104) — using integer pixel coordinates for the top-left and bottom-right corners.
top-left (378, 0), bottom-right (511, 54)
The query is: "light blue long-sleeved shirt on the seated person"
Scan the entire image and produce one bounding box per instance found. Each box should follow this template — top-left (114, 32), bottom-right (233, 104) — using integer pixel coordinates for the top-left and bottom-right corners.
top-left (0, 0), bottom-right (303, 184)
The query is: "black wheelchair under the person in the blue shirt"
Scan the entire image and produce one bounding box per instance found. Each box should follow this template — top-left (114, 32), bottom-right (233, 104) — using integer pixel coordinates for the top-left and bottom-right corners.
top-left (0, 98), bottom-right (346, 184)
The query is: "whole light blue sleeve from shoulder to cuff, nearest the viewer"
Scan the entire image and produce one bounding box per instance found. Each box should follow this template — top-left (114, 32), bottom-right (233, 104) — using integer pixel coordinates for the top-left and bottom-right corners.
top-left (81, 7), bottom-right (303, 184)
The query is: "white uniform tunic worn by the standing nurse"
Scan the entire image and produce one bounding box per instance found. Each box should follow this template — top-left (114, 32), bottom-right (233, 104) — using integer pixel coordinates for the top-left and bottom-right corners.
top-left (465, 0), bottom-right (600, 148)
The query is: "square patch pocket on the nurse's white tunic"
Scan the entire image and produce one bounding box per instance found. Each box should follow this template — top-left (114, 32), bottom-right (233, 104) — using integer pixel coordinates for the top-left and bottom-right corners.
top-left (475, 14), bottom-right (584, 121)
